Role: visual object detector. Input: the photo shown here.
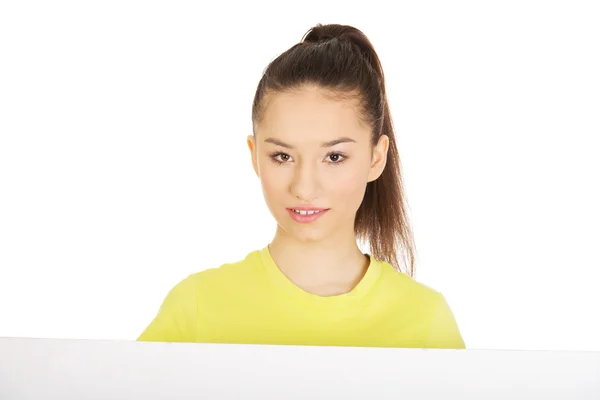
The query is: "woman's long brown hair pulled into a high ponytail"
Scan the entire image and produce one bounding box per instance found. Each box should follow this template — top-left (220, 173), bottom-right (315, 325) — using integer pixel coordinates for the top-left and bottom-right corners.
top-left (252, 24), bottom-right (416, 276)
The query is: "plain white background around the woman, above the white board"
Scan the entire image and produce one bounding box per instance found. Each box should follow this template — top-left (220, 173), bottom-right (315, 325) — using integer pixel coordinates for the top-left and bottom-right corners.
top-left (0, 0), bottom-right (600, 350)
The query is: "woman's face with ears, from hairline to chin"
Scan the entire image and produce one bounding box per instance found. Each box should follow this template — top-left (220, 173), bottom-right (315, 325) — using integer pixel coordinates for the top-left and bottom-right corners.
top-left (248, 86), bottom-right (388, 241)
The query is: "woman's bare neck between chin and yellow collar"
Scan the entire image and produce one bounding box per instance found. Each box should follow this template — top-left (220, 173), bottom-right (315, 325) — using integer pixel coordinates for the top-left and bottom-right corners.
top-left (269, 228), bottom-right (369, 295)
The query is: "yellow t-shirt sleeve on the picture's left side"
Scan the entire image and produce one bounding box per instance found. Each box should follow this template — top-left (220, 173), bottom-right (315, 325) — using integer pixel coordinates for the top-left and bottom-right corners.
top-left (137, 275), bottom-right (198, 342)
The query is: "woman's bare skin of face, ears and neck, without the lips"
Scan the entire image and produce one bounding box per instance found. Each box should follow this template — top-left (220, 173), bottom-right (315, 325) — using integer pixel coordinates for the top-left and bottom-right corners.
top-left (247, 86), bottom-right (389, 296)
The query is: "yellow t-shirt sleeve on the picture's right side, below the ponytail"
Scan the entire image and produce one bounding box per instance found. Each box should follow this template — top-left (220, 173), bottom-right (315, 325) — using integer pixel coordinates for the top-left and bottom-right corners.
top-left (427, 293), bottom-right (466, 349)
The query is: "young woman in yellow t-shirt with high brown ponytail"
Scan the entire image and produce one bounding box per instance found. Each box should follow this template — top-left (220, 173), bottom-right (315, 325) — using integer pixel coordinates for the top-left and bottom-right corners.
top-left (138, 24), bottom-right (465, 348)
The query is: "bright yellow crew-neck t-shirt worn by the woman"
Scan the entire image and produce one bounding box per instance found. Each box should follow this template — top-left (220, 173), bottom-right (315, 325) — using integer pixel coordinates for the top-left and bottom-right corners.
top-left (138, 246), bottom-right (465, 349)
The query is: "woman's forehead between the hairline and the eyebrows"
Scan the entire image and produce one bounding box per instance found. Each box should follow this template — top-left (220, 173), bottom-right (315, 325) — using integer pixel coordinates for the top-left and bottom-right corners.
top-left (258, 86), bottom-right (370, 144)
